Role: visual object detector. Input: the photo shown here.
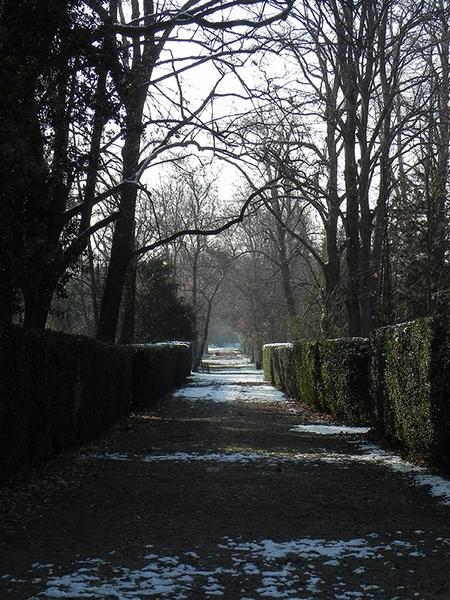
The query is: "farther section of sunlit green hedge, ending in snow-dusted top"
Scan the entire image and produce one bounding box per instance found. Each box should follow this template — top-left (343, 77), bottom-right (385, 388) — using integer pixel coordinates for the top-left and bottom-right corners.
top-left (263, 338), bottom-right (370, 424)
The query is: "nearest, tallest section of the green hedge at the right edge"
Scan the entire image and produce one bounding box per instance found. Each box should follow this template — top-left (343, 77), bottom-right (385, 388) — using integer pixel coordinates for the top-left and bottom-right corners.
top-left (370, 317), bottom-right (450, 464)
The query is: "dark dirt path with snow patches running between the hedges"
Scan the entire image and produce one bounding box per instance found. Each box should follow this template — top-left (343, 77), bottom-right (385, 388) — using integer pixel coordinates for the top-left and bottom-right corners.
top-left (0, 354), bottom-right (450, 600)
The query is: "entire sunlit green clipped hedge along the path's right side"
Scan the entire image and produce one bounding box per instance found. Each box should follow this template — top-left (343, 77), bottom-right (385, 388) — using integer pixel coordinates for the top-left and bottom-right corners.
top-left (263, 317), bottom-right (450, 464)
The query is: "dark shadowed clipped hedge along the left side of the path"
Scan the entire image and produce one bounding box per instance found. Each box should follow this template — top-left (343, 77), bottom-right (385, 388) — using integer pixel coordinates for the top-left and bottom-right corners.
top-left (0, 327), bottom-right (190, 475)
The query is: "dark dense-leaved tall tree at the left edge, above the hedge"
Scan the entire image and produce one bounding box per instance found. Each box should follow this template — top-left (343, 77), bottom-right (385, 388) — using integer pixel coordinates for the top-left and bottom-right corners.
top-left (0, 0), bottom-right (114, 328)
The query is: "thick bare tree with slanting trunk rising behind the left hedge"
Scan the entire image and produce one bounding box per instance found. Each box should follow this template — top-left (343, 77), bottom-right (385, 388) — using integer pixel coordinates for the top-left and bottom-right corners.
top-left (89, 0), bottom-right (287, 342)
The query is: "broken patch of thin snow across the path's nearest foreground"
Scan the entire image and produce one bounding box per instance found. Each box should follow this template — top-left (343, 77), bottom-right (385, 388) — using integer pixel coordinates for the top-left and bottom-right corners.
top-left (11, 531), bottom-right (450, 600)
